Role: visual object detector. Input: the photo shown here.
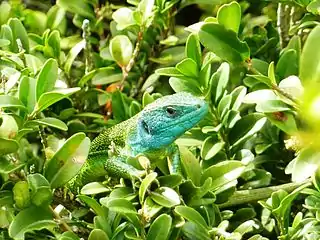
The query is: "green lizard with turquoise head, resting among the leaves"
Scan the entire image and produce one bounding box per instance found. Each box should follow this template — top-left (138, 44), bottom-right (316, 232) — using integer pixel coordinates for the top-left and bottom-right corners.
top-left (68, 93), bottom-right (208, 191)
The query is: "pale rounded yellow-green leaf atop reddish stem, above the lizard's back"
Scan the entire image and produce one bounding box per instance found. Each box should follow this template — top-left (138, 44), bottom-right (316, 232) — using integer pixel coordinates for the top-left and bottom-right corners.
top-left (109, 35), bottom-right (133, 67)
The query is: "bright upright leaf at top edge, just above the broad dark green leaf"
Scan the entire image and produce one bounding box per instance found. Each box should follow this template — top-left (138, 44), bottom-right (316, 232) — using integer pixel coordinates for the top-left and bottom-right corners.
top-left (217, 1), bottom-right (241, 33)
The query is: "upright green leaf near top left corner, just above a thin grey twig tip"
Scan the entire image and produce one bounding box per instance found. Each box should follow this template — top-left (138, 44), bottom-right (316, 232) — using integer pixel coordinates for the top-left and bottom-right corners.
top-left (8, 18), bottom-right (30, 53)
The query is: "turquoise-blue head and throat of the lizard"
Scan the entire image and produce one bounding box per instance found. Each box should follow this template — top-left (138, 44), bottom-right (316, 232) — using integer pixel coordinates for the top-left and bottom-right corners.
top-left (128, 92), bottom-right (208, 153)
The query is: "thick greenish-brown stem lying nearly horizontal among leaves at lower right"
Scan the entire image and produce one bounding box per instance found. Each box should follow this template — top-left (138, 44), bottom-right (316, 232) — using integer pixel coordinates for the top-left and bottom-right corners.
top-left (218, 179), bottom-right (311, 208)
